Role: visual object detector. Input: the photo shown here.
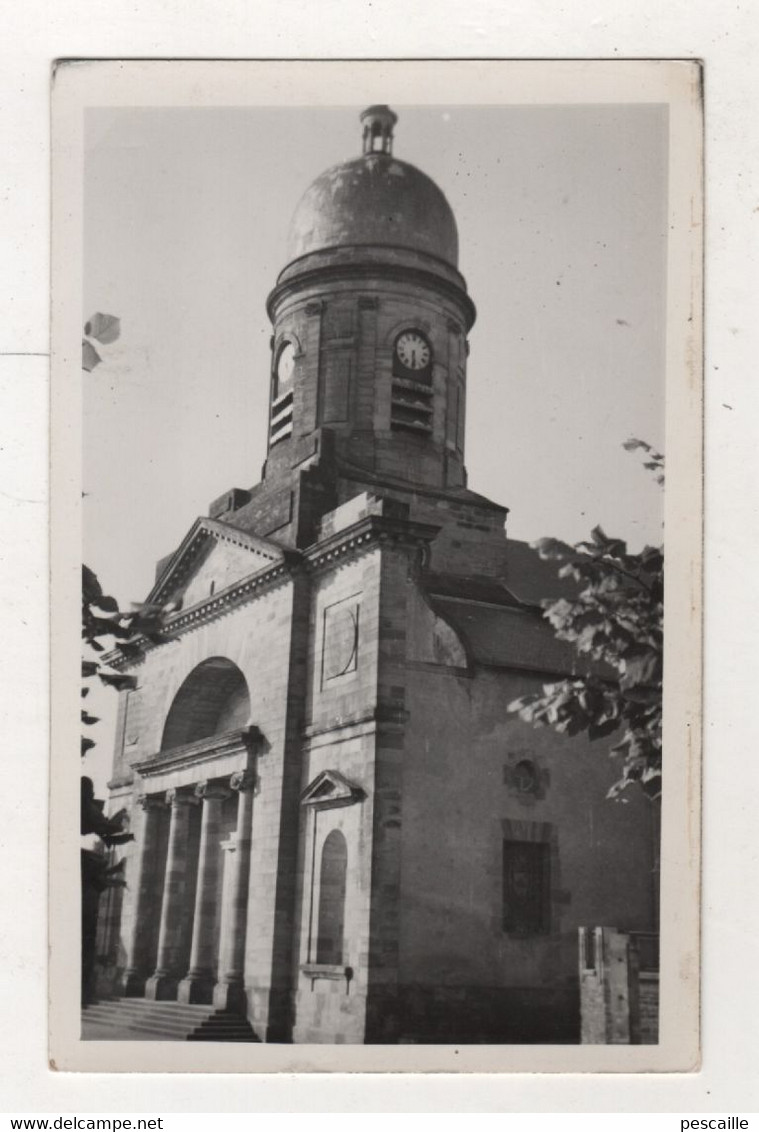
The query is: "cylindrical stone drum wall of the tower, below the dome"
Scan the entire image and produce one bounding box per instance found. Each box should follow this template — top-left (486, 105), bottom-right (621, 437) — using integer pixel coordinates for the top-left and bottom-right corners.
top-left (265, 267), bottom-right (468, 487)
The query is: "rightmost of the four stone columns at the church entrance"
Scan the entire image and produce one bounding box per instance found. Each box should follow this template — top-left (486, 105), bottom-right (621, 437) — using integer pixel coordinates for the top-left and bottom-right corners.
top-left (213, 771), bottom-right (256, 1011)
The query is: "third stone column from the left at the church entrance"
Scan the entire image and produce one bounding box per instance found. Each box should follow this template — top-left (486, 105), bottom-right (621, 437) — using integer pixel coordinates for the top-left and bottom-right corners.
top-left (177, 782), bottom-right (230, 1003)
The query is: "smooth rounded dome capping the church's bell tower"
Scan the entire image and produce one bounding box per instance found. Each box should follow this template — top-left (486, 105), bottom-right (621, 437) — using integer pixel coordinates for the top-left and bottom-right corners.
top-left (288, 117), bottom-right (459, 267)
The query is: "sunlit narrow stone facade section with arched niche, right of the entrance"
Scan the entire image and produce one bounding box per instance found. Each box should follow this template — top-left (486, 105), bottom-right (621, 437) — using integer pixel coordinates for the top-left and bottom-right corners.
top-left (293, 541), bottom-right (381, 1043)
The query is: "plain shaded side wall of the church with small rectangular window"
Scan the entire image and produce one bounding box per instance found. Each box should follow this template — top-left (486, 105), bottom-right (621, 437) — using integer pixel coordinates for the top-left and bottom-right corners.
top-left (369, 566), bottom-right (654, 1041)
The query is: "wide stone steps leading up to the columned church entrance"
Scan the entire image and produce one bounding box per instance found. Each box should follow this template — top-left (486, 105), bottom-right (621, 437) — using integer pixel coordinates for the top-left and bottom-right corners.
top-left (82, 998), bottom-right (261, 1041)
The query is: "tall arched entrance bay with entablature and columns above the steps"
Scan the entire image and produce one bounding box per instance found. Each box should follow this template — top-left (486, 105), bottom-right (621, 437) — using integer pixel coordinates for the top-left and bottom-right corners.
top-left (124, 657), bottom-right (250, 1002)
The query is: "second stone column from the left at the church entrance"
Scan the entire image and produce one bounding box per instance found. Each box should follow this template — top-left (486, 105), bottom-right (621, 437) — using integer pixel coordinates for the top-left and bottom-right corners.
top-left (145, 790), bottom-right (198, 998)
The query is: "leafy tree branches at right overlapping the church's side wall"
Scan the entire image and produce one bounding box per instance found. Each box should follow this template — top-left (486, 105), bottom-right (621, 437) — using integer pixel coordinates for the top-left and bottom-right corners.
top-left (509, 441), bottom-right (664, 800)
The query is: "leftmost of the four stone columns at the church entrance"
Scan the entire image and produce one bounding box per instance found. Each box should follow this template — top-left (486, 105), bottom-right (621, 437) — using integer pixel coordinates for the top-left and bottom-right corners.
top-left (121, 794), bottom-right (167, 997)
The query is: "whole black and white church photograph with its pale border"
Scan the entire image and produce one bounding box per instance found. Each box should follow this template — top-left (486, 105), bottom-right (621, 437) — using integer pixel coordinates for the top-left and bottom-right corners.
top-left (51, 61), bottom-right (701, 1072)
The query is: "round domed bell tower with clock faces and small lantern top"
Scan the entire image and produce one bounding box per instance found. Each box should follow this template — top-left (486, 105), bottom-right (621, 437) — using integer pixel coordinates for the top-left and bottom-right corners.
top-left (265, 106), bottom-right (475, 489)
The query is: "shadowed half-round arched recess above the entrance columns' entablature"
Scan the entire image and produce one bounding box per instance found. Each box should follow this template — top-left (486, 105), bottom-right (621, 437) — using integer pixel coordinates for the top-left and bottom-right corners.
top-left (161, 657), bottom-right (250, 751)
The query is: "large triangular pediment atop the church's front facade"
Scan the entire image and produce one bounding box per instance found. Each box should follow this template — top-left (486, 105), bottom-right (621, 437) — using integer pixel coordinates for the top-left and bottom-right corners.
top-left (147, 518), bottom-right (284, 609)
